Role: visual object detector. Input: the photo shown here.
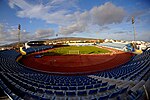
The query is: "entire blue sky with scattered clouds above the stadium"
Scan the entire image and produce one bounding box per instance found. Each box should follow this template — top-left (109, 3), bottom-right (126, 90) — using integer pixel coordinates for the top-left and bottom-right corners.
top-left (0, 0), bottom-right (150, 45)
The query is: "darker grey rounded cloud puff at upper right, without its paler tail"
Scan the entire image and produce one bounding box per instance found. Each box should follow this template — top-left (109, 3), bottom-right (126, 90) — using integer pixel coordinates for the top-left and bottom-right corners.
top-left (90, 2), bottom-right (126, 26)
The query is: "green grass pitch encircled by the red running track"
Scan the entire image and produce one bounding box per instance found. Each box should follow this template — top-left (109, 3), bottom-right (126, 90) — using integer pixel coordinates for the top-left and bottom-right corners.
top-left (43, 46), bottom-right (110, 55)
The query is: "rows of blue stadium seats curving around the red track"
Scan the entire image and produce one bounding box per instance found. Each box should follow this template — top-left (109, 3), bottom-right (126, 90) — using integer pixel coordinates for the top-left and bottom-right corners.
top-left (0, 46), bottom-right (150, 100)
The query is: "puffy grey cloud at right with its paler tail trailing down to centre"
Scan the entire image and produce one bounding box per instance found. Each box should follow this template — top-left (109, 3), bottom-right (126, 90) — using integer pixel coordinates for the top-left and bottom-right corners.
top-left (59, 2), bottom-right (126, 35)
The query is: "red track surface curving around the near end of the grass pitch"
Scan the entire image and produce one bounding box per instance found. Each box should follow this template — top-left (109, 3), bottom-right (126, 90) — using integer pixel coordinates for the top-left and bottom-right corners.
top-left (19, 49), bottom-right (133, 74)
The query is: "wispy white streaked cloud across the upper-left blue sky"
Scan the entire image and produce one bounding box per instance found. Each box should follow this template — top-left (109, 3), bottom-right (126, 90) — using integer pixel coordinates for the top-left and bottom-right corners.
top-left (9, 0), bottom-right (78, 25)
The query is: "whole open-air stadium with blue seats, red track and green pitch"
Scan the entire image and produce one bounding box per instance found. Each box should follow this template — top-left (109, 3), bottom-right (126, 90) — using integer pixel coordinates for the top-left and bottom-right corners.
top-left (0, 38), bottom-right (150, 100)
